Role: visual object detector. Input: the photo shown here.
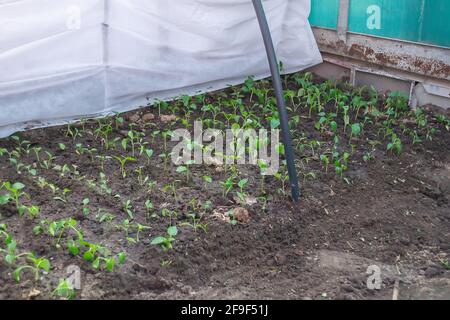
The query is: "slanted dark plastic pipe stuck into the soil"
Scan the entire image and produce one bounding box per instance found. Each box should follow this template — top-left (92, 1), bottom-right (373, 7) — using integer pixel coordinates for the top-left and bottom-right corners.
top-left (252, 0), bottom-right (300, 201)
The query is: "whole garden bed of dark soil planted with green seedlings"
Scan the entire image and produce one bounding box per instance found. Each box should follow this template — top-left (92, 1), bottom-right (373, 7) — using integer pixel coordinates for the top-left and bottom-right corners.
top-left (0, 74), bottom-right (450, 299)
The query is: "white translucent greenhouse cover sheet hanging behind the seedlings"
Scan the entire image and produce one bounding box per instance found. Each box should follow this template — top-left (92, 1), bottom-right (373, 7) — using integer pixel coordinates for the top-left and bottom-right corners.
top-left (0, 0), bottom-right (322, 136)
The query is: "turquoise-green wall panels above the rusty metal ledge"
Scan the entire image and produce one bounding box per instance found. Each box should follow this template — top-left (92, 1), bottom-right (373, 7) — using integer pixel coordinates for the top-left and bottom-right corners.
top-left (310, 0), bottom-right (450, 47)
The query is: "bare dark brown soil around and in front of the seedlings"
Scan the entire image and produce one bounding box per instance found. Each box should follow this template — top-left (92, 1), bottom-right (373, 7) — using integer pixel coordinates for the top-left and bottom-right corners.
top-left (0, 73), bottom-right (450, 299)
